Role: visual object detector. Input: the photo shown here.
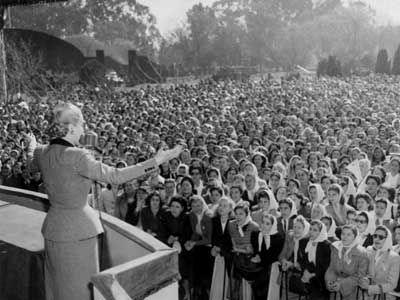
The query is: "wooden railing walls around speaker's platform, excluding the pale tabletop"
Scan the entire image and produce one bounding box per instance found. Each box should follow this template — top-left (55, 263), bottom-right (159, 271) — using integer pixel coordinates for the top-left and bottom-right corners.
top-left (0, 185), bottom-right (179, 300)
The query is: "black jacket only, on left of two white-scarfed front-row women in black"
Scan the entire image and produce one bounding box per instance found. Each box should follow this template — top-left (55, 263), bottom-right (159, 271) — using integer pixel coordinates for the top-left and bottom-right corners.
top-left (251, 231), bottom-right (285, 268)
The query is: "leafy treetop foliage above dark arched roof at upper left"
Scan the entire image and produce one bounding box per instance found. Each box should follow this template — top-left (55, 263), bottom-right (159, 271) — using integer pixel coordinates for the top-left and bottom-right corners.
top-left (11, 0), bottom-right (161, 57)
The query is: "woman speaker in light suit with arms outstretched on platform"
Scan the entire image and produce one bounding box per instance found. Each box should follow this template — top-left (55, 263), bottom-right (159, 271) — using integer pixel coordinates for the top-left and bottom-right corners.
top-left (28, 103), bottom-right (181, 300)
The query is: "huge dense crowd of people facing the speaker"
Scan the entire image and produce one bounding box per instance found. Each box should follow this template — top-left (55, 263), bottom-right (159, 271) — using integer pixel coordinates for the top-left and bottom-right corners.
top-left (0, 76), bottom-right (400, 300)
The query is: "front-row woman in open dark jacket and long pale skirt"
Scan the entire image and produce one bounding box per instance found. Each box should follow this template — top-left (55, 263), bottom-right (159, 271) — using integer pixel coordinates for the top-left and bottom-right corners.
top-left (210, 197), bottom-right (235, 300)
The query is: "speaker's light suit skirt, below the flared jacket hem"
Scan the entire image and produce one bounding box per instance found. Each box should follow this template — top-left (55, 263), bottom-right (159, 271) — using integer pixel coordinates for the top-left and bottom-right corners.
top-left (45, 236), bottom-right (99, 300)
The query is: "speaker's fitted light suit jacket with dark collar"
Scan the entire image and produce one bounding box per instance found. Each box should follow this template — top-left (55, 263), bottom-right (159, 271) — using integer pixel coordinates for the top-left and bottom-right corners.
top-left (30, 144), bottom-right (156, 241)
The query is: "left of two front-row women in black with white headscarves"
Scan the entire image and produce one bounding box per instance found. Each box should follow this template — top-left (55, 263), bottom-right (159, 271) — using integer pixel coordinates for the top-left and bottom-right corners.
top-left (251, 212), bottom-right (284, 300)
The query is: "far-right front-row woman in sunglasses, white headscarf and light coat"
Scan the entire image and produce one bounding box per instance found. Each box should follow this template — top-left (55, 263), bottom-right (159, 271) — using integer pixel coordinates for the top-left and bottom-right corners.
top-left (360, 226), bottom-right (400, 300)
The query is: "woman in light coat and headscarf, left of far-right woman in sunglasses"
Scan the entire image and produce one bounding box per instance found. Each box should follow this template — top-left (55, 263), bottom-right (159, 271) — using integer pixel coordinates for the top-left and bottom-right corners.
top-left (325, 225), bottom-right (368, 300)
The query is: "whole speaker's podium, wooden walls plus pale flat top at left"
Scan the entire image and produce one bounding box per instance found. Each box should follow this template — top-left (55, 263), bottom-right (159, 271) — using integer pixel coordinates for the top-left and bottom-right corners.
top-left (0, 186), bottom-right (179, 300)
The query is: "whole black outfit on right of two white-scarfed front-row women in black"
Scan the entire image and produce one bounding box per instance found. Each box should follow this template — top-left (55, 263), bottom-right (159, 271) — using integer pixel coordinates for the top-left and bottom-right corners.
top-left (298, 238), bottom-right (331, 300)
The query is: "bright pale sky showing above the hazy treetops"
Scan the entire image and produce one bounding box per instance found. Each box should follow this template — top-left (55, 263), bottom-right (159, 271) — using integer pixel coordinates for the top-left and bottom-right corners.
top-left (138, 0), bottom-right (400, 36)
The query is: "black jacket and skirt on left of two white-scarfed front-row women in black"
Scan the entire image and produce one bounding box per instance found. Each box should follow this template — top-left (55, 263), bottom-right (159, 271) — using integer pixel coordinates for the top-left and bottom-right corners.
top-left (251, 231), bottom-right (285, 300)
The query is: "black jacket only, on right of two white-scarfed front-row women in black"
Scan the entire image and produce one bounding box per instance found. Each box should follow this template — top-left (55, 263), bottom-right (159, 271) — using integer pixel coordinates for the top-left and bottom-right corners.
top-left (297, 238), bottom-right (331, 289)
